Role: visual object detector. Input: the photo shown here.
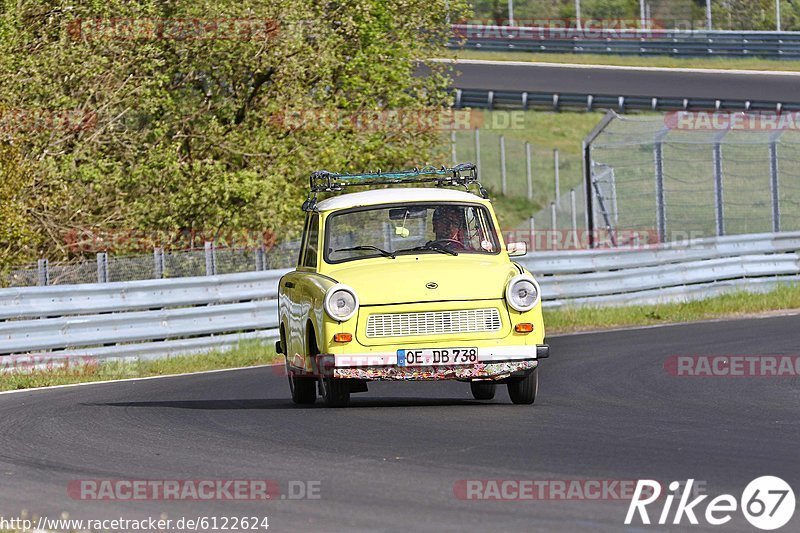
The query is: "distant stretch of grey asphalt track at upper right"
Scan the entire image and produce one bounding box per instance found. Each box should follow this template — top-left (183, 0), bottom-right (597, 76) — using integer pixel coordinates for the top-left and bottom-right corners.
top-left (434, 60), bottom-right (800, 103)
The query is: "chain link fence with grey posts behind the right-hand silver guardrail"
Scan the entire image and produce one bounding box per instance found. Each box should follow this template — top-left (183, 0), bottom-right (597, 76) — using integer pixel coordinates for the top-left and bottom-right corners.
top-left (588, 112), bottom-right (800, 242)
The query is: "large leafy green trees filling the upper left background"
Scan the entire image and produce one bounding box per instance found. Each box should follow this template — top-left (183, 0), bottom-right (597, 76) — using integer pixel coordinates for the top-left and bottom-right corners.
top-left (0, 0), bottom-right (466, 266)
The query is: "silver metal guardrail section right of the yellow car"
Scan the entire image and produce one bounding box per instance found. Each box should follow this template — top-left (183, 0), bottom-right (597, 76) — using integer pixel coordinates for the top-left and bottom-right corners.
top-left (520, 232), bottom-right (800, 308)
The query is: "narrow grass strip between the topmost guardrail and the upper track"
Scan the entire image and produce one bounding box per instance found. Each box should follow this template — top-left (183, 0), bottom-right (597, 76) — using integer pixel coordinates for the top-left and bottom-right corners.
top-left (455, 50), bottom-right (800, 71)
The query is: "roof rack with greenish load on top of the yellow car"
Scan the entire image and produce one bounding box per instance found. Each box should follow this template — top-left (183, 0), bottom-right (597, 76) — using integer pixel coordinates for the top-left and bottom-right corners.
top-left (303, 163), bottom-right (489, 211)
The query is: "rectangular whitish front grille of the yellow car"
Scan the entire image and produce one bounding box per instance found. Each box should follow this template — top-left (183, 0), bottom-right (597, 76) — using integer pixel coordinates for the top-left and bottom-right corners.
top-left (367, 308), bottom-right (502, 338)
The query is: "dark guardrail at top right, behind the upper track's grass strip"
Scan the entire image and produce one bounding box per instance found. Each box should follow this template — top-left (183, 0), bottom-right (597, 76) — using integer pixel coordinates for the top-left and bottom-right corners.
top-left (450, 24), bottom-right (800, 59)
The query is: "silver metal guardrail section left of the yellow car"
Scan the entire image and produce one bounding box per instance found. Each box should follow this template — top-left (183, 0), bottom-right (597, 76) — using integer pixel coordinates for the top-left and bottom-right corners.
top-left (0, 270), bottom-right (287, 360)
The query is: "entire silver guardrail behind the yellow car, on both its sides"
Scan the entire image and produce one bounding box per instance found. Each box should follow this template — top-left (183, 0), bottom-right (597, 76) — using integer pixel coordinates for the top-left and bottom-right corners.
top-left (0, 232), bottom-right (800, 362)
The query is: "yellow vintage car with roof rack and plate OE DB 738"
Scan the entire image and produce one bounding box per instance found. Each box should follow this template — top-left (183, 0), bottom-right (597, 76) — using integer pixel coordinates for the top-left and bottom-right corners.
top-left (276, 164), bottom-right (549, 407)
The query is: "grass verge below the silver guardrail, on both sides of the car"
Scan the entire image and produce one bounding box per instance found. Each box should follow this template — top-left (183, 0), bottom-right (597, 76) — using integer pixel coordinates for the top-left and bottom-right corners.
top-left (0, 284), bottom-right (800, 393)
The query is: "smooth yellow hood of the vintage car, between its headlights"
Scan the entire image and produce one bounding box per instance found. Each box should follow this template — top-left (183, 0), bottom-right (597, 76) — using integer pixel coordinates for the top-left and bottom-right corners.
top-left (327, 254), bottom-right (519, 305)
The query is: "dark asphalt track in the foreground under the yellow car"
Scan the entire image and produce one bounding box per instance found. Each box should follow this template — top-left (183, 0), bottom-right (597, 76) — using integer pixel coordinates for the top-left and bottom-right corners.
top-left (0, 316), bottom-right (800, 531)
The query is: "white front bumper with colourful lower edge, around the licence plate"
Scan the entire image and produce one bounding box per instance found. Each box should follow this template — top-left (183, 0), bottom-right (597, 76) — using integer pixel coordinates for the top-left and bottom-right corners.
top-left (308, 344), bottom-right (550, 381)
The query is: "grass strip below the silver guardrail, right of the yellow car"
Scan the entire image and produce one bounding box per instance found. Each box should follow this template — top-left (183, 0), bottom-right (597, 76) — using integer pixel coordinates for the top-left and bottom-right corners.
top-left (544, 284), bottom-right (800, 334)
